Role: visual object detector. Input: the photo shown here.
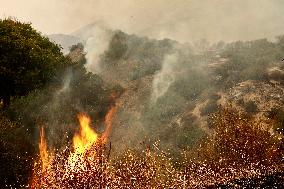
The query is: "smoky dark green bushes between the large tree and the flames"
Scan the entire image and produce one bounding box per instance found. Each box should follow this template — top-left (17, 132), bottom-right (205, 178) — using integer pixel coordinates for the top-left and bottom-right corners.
top-left (9, 45), bottom-right (122, 147)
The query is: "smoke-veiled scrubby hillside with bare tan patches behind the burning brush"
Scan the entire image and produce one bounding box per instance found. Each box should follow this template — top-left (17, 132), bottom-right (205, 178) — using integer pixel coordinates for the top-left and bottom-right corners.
top-left (60, 25), bottom-right (284, 152)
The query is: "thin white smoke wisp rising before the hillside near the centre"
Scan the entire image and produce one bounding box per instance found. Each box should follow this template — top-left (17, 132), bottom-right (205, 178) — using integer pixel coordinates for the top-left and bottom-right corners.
top-left (151, 54), bottom-right (177, 103)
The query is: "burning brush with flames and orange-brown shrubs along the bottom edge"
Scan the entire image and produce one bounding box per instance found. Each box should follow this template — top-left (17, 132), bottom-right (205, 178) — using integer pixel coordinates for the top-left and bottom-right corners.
top-left (27, 109), bottom-right (283, 188)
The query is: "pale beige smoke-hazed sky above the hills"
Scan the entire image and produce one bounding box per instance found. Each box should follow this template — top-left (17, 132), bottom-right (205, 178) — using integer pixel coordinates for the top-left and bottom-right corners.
top-left (0, 0), bottom-right (284, 42)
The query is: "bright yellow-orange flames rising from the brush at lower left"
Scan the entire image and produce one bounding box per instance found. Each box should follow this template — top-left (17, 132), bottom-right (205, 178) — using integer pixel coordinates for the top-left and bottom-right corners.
top-left (30, 106), bottom-right (116, 188)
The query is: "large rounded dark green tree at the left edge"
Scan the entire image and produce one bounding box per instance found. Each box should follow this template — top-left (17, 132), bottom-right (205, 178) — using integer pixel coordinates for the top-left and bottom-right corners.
top-left (0, 19), bottom-right (68, 107)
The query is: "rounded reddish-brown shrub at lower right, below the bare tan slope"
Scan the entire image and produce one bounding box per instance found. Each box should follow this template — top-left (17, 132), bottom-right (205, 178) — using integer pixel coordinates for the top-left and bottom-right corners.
top-left (195, 109), bottom-right (283, 167)
